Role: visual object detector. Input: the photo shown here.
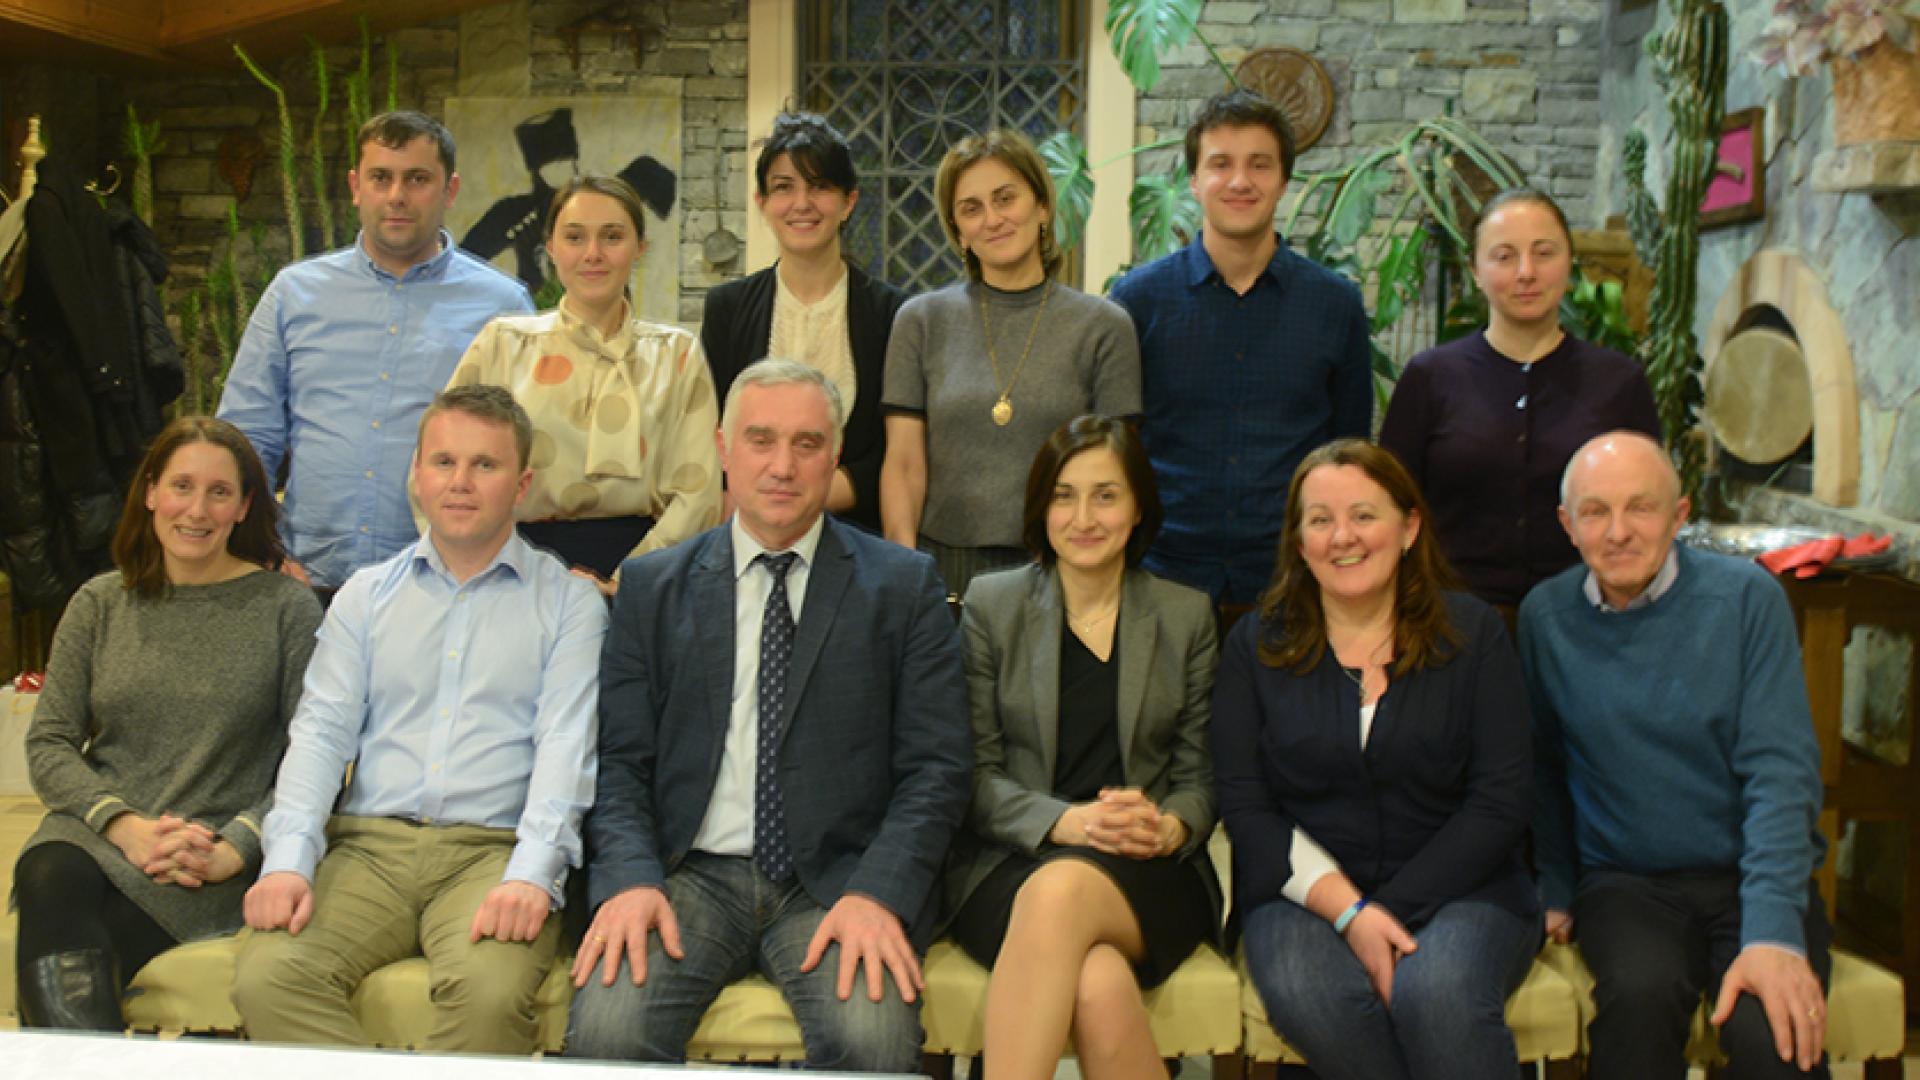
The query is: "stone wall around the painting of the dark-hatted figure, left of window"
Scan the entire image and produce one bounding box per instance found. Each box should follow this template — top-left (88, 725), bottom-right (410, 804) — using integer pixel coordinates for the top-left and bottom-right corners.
top-left (100, 0), bottom-right (747, 323)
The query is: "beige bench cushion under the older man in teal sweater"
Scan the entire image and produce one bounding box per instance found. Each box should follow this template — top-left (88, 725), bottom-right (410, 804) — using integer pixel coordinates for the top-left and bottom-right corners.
top-left (1534, 945), bottom-right (1907, 1080)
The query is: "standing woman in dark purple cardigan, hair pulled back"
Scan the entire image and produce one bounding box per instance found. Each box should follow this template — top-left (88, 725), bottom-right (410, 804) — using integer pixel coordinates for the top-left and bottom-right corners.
top-left (1380, 188), bottom-right (1661, 611)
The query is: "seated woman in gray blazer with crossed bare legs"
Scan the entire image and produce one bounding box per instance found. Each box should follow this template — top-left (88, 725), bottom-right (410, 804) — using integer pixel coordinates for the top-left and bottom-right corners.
top-left (947, 415), bottom-right (1221, 1080)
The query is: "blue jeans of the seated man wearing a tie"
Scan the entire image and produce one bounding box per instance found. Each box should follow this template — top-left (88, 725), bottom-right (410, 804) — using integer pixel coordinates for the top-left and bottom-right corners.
top-left (566, 851), bottom-right (924, 1072)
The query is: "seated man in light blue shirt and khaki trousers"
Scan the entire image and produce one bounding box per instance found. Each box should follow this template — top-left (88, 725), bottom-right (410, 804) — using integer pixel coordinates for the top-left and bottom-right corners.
top-left (232, 386), bottom-right (607, 1053)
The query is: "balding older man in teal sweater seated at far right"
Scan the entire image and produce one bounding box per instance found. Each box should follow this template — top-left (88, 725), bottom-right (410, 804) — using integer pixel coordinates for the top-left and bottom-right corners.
top-left (1519, 432), bottom-right (1830, 1080)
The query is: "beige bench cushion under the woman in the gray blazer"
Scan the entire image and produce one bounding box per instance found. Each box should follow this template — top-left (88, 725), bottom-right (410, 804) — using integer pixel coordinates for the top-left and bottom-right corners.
top-left (920, 942), bottom-right (1240, 1057)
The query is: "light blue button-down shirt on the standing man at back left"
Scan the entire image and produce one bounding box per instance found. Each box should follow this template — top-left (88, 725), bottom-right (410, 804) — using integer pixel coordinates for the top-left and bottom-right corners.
top-left (219, 229), bottom-right (534, 586)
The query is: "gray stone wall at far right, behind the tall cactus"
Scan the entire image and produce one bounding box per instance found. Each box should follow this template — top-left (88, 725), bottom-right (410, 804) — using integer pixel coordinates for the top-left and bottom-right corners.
top-left (1594, 4), bottom-right (1920, 538)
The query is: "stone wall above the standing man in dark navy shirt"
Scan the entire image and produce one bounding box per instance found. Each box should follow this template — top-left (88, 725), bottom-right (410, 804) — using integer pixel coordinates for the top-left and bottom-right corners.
top-left (1137, 0), bottom-right (1603, 227)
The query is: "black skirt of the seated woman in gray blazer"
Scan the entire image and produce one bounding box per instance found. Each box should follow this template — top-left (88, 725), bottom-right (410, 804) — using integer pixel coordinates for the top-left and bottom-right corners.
top-left (947, 844), bottom-right (1217, 990)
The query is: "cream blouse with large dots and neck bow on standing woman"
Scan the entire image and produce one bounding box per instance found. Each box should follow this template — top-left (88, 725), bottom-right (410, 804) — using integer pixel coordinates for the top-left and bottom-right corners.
top-left (447, 302), bottom-right (720, 555)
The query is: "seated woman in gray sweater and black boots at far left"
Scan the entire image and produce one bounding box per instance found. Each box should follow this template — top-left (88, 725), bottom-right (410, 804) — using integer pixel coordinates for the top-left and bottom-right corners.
top-left (13, 417), bottom-right (321, 1030)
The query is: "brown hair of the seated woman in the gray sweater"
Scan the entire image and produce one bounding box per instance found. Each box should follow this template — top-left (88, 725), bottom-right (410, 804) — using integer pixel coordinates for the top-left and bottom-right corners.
top-left (113, 417), bottom-right (286, 598)
